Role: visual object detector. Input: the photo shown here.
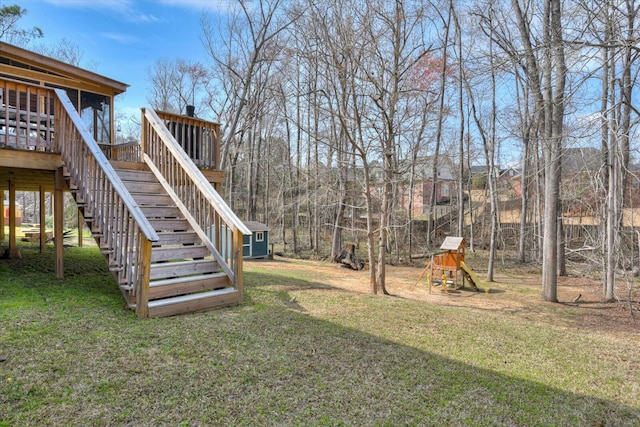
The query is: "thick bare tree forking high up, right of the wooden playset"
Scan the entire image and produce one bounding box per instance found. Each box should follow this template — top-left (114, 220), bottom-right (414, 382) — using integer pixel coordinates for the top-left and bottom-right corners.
top-left (480, 0), bottom-right (567, 302)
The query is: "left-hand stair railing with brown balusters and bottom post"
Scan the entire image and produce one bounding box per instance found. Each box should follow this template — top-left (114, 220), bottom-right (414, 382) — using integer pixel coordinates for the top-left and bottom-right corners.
top-left (55, 89), bottom-right (158, 317)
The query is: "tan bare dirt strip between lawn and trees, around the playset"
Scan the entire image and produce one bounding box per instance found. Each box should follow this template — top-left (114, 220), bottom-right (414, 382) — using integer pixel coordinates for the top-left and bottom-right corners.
top-left (249, 257), bottom-right (640, 340)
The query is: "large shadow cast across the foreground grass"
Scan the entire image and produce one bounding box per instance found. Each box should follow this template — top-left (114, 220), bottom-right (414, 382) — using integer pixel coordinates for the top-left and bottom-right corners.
top-left (0, 249), bottom-right (640, 426)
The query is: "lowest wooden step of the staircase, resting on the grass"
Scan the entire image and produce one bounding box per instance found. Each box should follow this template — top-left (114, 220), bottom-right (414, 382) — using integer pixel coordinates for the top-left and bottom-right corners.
top-left (149, 288), bottom-right (241, 317)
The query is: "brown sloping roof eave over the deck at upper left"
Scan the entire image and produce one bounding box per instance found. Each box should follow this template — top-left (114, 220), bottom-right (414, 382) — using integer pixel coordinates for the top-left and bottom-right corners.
top-left (0, 42), bottom-right (129, 95)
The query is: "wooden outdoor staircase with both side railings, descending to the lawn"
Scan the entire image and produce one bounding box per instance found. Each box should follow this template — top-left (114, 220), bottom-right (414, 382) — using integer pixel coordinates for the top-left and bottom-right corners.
top-left (55, 89), bottom-right (251, 317)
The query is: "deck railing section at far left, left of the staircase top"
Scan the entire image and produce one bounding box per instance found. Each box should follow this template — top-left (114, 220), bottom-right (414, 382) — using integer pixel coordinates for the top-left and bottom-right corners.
top-left (0, 79), bottom-right (55, 151)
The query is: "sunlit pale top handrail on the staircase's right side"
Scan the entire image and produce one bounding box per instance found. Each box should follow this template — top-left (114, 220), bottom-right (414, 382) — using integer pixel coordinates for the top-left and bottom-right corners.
top-left (142, 108), bottom-right (251, 235)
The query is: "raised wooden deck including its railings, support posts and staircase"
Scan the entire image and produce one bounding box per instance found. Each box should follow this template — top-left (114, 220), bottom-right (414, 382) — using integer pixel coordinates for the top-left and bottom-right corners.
top-left (0, 81), bottom-right (249, 317)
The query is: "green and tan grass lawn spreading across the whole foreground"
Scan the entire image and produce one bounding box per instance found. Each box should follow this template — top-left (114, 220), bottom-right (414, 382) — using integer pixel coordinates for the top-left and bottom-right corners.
top-left (0, 245), bottom-right (640, 426)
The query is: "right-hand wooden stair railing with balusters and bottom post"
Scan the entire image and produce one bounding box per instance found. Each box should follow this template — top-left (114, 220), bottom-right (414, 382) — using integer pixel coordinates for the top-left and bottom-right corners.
top-left (142, 108), bottom-right (251, 296)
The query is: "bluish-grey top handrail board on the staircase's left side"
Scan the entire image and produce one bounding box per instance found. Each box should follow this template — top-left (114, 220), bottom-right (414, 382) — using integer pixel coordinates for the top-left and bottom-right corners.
top-left (54, 89), bottom-right (159, 242)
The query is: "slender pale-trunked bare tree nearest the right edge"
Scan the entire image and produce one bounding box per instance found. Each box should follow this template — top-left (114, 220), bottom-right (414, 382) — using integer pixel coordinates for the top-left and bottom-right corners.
top-left (582, 0), bottom-right (640, 300)
